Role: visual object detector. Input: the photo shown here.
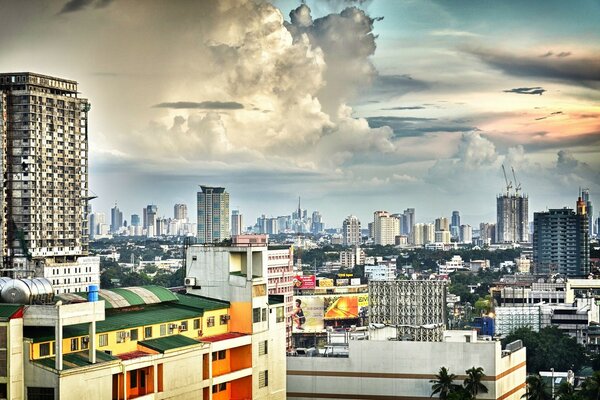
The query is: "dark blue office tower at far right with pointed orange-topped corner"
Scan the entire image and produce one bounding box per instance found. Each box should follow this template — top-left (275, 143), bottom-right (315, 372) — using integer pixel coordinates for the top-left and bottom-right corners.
top-left (533, 197), bottom-right (589, 276)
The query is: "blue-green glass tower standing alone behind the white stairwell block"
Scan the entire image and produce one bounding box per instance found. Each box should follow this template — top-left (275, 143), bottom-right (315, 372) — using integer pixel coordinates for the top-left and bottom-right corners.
top-left (198, 186), bottom-right (230, 243)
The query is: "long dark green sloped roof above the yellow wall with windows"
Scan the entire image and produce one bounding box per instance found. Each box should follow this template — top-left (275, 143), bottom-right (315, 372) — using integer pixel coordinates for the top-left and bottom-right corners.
top-left (23, 303), bottom-right (202, 343)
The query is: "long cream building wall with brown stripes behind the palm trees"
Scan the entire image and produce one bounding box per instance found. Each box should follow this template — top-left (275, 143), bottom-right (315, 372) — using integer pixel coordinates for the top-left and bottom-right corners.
top-left (287, 341), bottom-right (525, 400)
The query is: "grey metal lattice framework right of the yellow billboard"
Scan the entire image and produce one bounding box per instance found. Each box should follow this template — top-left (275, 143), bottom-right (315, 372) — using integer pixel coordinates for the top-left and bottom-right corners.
top-left (369, 280), bottom-right (446, 342)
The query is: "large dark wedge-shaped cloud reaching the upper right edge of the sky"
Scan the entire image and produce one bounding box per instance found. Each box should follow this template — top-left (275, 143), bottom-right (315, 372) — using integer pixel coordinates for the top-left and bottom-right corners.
top-left (466, 48), bottom-right (600, 87)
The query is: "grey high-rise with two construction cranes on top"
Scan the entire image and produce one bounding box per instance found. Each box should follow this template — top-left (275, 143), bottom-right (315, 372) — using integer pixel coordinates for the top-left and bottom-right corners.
top-left (496, 193), bottom-right (529, 243)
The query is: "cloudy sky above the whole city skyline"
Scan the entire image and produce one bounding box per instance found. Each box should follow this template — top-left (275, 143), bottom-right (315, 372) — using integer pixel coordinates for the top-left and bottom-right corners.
top-left (0, 0), bottom-right (600, 227)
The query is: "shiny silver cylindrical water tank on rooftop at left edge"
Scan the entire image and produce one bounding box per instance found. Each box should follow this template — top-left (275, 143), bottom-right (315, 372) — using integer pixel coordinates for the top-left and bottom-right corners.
top-left (0, 278), bottom-right (54, 304)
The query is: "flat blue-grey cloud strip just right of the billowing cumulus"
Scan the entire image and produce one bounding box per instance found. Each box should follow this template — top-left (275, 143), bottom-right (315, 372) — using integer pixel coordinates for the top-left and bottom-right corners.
top-left (366, 116), bottom-right (479, 137)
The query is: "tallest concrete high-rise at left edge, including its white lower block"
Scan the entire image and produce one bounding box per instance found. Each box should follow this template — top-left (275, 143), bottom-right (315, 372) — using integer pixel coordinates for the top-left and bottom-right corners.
top-left (0, 72), bottom-right (99, 292)
